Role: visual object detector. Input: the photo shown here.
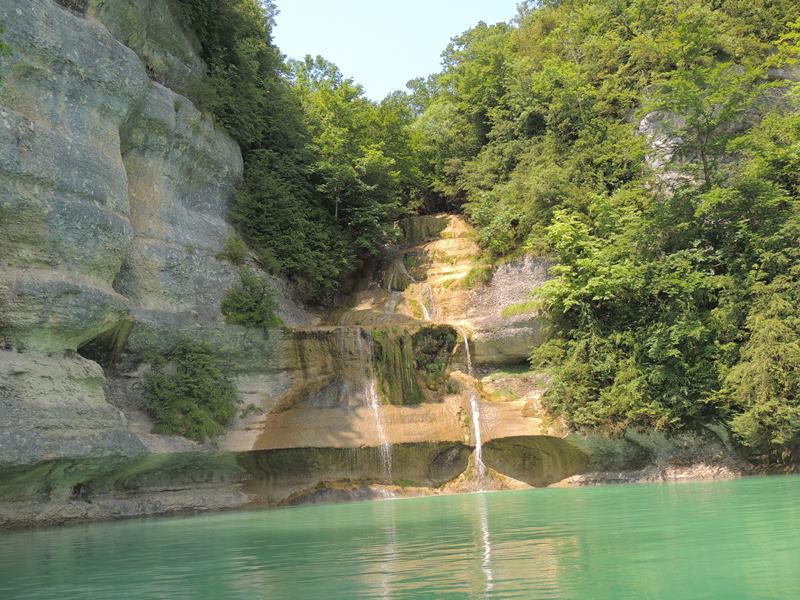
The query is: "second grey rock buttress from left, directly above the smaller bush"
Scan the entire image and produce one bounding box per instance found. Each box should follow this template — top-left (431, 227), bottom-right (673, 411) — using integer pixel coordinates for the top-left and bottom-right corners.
top-left (116, 83), bottom-right (242, 319)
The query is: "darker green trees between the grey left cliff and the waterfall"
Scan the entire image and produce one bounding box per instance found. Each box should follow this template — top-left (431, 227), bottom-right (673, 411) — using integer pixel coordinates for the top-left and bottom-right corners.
top-left (176, 0), bottom-right (419, 303)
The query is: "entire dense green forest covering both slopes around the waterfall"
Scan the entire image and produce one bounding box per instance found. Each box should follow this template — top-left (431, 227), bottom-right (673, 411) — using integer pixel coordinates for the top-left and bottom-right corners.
top-left (176, 0), bottom-right (800, 455)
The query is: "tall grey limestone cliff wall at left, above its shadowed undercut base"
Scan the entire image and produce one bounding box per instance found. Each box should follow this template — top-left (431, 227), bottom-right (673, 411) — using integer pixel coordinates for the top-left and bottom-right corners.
top-left (0, 0), bottom-right (286, 463)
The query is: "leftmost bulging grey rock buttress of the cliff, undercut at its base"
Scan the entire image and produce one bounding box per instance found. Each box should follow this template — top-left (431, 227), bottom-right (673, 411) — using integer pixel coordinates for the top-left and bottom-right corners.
top-left (0, 0), bottom-right (149, 351)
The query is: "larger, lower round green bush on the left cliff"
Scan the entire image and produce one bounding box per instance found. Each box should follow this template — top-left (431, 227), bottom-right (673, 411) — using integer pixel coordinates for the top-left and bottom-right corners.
top-left (142, 341), bottom-right (236, 441)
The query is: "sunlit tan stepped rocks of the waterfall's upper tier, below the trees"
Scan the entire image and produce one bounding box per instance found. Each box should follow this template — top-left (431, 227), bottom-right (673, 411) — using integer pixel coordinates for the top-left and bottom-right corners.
top-left (332, 215), bottom-right (552, 366)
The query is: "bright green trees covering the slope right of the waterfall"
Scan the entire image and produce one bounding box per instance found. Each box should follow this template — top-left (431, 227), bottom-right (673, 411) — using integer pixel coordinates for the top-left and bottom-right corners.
top-left (411, 0), bottom-right (800, 456)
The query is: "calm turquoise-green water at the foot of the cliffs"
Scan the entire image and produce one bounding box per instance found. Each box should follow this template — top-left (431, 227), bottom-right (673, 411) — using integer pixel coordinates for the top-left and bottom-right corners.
top-left (0, 477), bottom-right (800, 600)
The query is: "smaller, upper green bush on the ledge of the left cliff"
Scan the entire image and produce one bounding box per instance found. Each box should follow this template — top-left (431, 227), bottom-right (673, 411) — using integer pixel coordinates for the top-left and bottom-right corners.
top-left (221, 267), bottom-right (283, 329)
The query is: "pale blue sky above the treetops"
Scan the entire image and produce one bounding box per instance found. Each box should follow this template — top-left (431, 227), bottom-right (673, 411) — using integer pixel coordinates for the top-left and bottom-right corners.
top-left (274, 0), bottom-right (518, 100)
